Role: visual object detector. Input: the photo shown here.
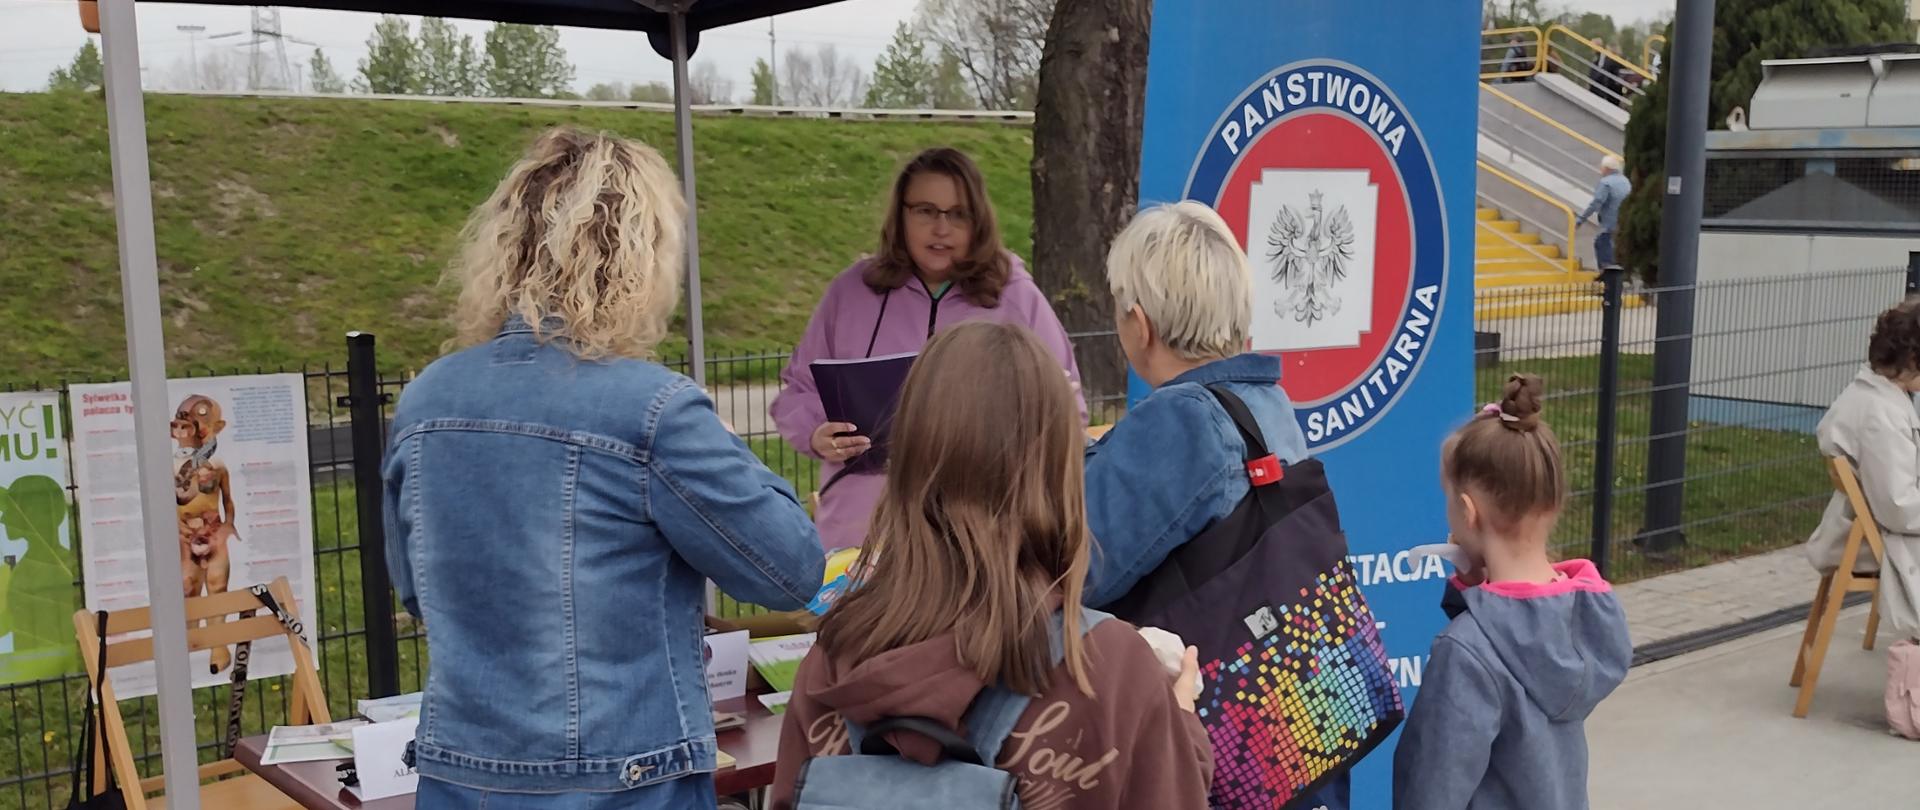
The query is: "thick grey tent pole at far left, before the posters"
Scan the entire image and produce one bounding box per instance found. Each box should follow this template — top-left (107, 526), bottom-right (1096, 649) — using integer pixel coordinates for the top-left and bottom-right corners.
top-left (96, 0), bottom-right (200, 810)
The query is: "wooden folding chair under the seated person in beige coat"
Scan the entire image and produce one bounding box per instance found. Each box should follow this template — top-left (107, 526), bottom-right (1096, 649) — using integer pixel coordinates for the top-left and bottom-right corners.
top-left (1788, 459), bottom-right (1887, 718)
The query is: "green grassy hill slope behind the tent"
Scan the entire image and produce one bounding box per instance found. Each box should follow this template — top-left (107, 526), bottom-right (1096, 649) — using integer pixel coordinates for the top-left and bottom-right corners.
top-left (0, 94), bottom-right (1033, 382)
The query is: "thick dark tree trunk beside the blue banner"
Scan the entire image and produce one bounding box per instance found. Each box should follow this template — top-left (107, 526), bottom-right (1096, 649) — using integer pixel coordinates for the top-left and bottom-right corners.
top-left (1033, 0), bottom-right (1154, 418)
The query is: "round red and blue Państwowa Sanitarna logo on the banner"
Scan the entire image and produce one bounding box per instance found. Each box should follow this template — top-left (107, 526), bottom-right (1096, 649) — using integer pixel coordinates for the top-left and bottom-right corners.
top-left (1185, 60), bottom-right (1448, 451)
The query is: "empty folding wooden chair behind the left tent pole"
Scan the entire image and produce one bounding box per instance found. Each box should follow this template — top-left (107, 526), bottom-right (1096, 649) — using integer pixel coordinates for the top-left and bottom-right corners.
top-left (73, 578), bottom-right (330, 810)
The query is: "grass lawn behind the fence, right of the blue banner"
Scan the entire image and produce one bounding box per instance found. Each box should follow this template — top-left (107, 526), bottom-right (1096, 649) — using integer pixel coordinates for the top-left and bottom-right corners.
top-left (1475, 355), bottom-right (1832, 582)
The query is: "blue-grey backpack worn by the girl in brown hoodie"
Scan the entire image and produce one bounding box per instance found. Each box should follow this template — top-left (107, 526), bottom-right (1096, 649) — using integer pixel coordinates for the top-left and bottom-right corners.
top-left (793, 608), bottom-right (1114, 810)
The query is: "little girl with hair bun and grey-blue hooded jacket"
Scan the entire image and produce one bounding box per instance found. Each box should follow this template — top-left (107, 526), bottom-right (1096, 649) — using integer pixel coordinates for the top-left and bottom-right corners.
top-left (1394, 374), bottom-right (1632, 810)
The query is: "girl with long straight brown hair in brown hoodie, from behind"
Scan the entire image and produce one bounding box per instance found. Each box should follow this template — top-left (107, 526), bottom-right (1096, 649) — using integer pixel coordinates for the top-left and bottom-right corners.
top-left (774, 322), bottom-right (1212, 810)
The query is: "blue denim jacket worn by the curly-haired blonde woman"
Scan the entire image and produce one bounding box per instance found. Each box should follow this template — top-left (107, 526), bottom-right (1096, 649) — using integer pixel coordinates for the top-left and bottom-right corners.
top-left (384, 321), bottom-right (824, 793)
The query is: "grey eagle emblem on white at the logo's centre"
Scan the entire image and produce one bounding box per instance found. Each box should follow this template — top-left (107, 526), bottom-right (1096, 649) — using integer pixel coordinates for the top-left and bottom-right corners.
top-left (1267, 192), bottom-right (1354, 326)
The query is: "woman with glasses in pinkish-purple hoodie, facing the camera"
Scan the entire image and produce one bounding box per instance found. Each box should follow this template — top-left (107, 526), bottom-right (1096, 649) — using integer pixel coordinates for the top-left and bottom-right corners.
top-left (770, 148), bottom-right (1087, 551)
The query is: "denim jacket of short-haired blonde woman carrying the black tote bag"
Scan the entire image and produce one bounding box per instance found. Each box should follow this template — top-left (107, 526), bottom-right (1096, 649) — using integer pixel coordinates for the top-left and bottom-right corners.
top-left (1087, 353), bottom-right (1308, 605)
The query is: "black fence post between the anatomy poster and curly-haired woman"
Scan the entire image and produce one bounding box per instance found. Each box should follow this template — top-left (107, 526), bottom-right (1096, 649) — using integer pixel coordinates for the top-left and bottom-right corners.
top-left (342, 332), bottom-right (399, 697)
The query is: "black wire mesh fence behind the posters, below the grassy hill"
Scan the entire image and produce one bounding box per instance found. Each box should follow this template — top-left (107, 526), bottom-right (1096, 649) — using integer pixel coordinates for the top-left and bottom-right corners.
top-left (0, 332), bottom-right (1125, 810)
